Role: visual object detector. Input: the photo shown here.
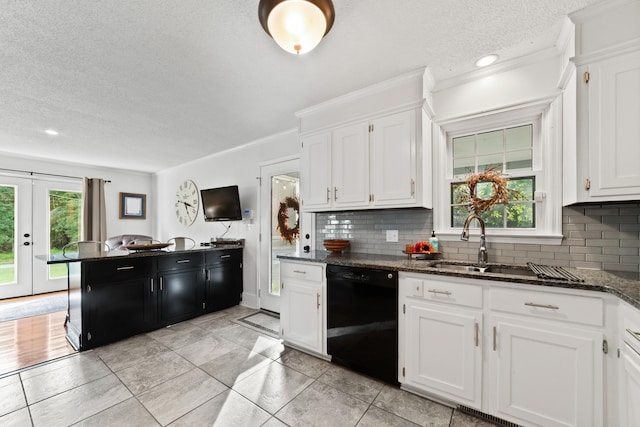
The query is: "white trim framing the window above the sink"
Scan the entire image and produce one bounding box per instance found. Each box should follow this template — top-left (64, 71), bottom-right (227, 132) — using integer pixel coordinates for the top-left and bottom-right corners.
top-left (433, 94), bottom-right (562, 245)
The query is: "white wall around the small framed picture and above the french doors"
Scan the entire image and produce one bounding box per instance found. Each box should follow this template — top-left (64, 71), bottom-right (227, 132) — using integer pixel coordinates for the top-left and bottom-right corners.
top-left (0, 154), bottom-right (155, 236)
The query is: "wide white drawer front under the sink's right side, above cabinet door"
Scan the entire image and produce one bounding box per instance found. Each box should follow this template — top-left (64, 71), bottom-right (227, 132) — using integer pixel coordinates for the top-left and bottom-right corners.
top-left (491, 288), bottom-right (604, 326)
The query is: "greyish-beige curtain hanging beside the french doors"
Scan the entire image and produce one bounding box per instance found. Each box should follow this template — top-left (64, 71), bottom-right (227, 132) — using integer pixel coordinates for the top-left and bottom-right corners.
top-left (80, 177), bottom-right (107, 242)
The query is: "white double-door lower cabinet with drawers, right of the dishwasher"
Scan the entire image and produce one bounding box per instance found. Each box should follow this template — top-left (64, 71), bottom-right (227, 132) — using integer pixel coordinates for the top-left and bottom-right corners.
top-left (399, 273), bottom-right (604, 427)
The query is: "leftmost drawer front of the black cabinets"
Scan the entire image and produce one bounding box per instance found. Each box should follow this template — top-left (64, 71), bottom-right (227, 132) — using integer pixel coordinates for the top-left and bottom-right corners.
top-left (82, 257), bottom-right (153, 284)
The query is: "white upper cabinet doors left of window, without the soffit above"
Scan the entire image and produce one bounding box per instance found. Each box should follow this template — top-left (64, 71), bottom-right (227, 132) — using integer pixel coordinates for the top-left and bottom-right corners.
top-left (302, 110), bottom-right (422, 212)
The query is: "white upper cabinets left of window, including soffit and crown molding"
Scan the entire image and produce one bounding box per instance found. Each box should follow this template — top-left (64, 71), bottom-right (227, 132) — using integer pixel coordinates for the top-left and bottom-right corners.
top-left (297, 69), bottom-right (432, 212)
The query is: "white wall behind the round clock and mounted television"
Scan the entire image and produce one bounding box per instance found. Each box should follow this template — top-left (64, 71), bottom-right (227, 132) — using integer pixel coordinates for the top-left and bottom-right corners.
top-left (153, 129), bottom-right (300, 307)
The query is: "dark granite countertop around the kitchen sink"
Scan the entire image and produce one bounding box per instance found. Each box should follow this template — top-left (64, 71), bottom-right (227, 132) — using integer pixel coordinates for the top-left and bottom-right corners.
top-left (278, 251), bottom-right (640, 309)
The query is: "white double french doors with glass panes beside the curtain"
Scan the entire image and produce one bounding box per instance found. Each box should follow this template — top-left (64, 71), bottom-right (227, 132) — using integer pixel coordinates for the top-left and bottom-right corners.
top-left (0, 176), bottom-right (82, 299)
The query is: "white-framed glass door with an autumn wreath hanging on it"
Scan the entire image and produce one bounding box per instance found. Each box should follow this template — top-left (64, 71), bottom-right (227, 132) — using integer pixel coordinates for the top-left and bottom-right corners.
top-left (259, 159), bottom-right (301, 313)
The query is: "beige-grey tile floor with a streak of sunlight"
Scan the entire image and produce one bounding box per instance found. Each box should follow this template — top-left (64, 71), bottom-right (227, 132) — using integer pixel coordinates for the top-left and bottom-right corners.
top-left (0, 307), bottom-right (491, 427)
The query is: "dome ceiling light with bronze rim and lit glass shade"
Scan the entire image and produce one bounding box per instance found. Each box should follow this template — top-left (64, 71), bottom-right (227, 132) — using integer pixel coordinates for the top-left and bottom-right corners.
top-left (258, 0), bottom-right (335, 54)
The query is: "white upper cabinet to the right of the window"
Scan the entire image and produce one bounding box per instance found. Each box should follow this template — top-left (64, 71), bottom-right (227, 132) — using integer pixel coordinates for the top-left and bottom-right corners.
top-left (565, 0), bottom-right (640, 203)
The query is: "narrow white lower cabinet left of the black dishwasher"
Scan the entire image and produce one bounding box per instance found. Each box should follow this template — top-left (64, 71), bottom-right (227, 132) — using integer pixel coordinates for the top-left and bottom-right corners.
top-left (280, 260), bottom-right (326, 356)
